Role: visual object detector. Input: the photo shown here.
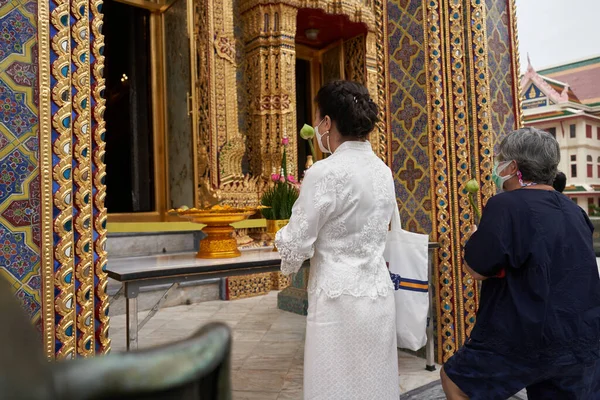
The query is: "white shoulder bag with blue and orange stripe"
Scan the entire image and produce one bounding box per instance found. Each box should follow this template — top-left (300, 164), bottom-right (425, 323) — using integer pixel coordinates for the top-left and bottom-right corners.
top-left (384, 208), bottom-right (429, 351)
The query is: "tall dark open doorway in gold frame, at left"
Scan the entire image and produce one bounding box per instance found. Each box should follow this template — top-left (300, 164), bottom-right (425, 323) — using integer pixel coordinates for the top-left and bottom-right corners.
top-left (103, 0), bottom-right (156, 213)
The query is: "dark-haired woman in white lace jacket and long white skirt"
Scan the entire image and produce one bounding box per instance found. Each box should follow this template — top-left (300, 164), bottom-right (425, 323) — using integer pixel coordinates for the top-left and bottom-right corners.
top-left (276, 81), bottom-right (400, 400)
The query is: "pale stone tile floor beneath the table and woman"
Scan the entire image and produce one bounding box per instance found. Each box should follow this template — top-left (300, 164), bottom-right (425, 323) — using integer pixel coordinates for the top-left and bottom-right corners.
top-left (110, 292), bottom-right (439, 400)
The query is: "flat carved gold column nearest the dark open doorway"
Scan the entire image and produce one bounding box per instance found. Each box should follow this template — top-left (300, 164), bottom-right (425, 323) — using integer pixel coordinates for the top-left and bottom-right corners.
top-left (192, 0), bottom-right (247, 208)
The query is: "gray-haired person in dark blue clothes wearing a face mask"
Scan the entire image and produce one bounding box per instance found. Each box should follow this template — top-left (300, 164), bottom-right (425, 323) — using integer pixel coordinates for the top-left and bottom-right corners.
top-left (441, 128), bottom-right (600, 400)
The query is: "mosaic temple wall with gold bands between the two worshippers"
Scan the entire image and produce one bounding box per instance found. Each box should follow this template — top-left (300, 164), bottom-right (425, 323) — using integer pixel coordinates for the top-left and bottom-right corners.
top-left (387, 0), bottom-right (520, 362)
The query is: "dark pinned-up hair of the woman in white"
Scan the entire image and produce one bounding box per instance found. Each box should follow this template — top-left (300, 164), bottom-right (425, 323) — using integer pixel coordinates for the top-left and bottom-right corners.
top-left (316, 81), bottom-right (379, 139)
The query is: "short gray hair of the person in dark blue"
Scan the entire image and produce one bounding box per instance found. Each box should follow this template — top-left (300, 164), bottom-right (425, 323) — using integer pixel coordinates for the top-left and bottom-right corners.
top-left (498, 127), bottom-right (560, 185)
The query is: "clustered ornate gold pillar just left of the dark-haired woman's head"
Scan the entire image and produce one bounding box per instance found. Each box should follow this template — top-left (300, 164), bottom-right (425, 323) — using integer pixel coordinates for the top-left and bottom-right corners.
top-left (241, 4), bottom-right (298, 178)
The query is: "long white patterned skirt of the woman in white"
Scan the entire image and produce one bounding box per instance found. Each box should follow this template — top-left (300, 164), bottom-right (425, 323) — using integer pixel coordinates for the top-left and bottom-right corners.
top-left (304, 292), bottom-right (400, 400)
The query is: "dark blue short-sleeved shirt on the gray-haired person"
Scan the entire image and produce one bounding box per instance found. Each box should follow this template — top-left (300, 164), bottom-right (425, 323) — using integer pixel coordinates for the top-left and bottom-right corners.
top-left (465, 189), bottom-right (600, 365)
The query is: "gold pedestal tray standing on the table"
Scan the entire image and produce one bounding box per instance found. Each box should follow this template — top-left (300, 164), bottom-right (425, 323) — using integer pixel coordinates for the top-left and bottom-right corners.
top-left (171, 206), bottom-right (257, 259)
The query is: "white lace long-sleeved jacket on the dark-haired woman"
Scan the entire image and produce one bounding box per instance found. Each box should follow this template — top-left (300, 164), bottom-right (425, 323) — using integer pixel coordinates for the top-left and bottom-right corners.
top-left (275, 141), bottom-right (397, 298)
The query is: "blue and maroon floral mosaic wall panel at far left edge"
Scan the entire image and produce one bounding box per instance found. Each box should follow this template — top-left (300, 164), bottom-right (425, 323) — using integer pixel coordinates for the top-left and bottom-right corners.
top-left (0, 1), bottom-right (42, 330)
